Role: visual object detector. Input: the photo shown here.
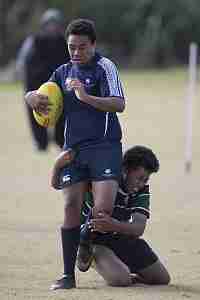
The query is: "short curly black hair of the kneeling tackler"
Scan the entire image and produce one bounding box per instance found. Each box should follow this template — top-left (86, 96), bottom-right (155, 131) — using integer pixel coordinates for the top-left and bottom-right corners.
top-left (122, 145), bottom-right (160, 173)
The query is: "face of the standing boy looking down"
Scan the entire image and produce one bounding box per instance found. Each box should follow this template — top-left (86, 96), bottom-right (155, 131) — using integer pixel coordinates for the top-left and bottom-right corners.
top-left (67, 34), bottom-right (96, 64)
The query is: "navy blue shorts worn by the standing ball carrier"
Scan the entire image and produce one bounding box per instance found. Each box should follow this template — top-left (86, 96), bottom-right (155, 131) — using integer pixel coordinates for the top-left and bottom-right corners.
top-left (59, 142), bottom-right (122, 188)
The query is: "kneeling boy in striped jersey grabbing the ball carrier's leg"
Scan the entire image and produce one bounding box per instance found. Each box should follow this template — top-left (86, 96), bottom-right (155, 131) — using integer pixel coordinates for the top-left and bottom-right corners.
top-left (77, 146), bottom-right (170, 286)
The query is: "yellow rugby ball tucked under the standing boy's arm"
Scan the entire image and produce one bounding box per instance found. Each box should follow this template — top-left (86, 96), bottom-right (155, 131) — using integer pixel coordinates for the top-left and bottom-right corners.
top-left (33, 81), bottom-right (63, 127)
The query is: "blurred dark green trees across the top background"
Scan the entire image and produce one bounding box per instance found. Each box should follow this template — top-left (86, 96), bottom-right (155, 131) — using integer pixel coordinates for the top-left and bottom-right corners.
top-left (0, 0), bottom-right (200, 67)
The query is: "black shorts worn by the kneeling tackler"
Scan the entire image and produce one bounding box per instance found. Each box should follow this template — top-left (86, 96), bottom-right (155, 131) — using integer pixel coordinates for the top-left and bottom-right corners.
top-left (94, 234), bottom-right (158, 273)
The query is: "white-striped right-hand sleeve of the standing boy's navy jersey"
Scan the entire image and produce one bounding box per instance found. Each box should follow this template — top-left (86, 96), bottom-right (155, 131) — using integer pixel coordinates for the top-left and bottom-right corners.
top-left (98, 57), bottom-right (124, 99)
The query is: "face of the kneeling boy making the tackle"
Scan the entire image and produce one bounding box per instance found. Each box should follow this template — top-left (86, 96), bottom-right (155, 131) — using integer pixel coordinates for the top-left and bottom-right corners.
top-left (126, 167), bottom-right (151, 193)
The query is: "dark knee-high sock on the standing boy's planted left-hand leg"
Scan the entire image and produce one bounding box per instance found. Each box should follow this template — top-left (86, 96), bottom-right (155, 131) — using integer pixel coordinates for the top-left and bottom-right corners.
top-left (61, 226), bottom-right (80, 276)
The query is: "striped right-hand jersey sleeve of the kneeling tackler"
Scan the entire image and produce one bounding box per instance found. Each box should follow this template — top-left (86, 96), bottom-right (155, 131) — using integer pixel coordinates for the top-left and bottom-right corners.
top-left (132, 185), bottom-right (150, 218)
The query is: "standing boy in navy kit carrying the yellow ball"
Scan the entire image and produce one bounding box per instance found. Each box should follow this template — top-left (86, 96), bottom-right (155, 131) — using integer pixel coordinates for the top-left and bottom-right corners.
top-left (25, 19), bottom-right (125, 289)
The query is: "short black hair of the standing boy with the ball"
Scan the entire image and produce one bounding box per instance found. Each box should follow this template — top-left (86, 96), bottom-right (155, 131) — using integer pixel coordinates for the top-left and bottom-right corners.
top-left (65, 19), bottom-right (96, 43)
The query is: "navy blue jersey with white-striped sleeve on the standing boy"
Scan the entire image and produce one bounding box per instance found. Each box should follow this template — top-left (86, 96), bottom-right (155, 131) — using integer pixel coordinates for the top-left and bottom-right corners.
top-left (50, 53), bottom-right (124, 148)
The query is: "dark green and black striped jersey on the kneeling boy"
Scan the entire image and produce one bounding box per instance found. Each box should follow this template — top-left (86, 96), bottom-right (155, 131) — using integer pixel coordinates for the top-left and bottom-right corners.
top-left (81, 185), bottom-right (150, 223)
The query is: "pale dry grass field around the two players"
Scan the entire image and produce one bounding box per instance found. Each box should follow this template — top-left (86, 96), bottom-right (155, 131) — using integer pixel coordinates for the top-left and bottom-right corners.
top-left (0, 69), bottom-right (200, 300)
